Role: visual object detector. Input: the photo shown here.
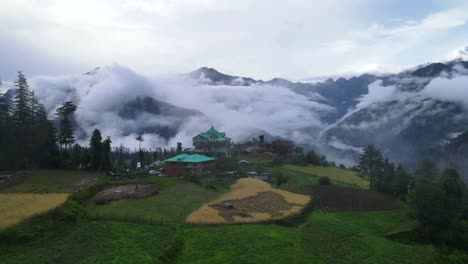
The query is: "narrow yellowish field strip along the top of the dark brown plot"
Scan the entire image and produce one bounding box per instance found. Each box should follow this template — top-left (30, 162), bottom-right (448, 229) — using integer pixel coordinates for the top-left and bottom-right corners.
top-left (281, 164), bottom-right (369, 189)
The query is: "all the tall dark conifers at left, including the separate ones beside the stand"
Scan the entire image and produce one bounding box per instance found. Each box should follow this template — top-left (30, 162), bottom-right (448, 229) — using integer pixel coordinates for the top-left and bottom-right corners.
top-left (0, 71), bottom-right (113, 170)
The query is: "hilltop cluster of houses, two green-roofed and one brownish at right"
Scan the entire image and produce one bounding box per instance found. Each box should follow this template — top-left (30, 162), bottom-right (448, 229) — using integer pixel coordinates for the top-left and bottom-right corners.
top-left (164, 127), bottom-right (294, 176)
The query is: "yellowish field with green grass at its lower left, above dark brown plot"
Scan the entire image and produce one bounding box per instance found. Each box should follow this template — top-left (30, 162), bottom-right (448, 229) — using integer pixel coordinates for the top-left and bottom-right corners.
top-left (281, 164), bottom-right (369, 191)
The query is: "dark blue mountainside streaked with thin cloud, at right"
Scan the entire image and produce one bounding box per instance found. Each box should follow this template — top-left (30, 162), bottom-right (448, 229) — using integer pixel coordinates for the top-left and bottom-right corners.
top-left (186, 58), bottom-right (468, 177)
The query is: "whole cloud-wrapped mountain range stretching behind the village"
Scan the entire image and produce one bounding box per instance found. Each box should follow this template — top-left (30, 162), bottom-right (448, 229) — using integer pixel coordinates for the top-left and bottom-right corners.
top-left (0, 50), bottom-right (468, 177)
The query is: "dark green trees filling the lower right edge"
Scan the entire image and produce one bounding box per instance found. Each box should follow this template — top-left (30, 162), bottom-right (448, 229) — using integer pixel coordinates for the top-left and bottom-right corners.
top-left (357, 146), bottom-right (468, 250)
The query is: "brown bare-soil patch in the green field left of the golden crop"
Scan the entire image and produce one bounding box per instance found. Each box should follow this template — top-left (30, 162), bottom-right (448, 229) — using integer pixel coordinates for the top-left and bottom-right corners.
top-left (93, 183), bottom-right (159, 204)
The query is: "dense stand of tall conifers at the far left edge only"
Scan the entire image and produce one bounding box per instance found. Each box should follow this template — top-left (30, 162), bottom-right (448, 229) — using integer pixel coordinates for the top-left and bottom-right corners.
top-left (0, 72), bottom-right (60, 170)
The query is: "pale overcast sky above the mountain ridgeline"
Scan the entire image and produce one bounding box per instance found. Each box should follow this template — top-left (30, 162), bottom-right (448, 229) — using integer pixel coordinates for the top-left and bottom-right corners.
top-left (0, 0), bottom-right (468, 80)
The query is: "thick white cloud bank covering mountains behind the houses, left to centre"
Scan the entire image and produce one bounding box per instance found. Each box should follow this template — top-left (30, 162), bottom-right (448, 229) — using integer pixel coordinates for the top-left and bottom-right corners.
top-left (22, 65), bottom-right (333, 149)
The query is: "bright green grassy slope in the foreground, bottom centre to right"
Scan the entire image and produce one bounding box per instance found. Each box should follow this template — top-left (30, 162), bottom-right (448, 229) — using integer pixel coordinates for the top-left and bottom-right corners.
top-left (179, 211), bottom-right (435, 264)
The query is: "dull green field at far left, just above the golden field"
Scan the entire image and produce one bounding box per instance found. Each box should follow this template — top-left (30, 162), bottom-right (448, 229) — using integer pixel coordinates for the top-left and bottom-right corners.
top-left (2, 170), bottom-right (102, 193)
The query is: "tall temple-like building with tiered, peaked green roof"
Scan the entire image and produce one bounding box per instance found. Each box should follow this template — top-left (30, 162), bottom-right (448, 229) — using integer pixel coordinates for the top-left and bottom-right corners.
top-left (193, 127), bottom-right (231, 157)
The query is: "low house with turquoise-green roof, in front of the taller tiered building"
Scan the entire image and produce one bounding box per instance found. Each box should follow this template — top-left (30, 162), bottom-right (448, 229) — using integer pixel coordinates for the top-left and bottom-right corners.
top-left (164, 154), bottom-right (215, 177)
